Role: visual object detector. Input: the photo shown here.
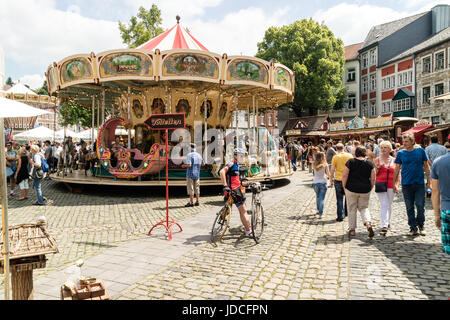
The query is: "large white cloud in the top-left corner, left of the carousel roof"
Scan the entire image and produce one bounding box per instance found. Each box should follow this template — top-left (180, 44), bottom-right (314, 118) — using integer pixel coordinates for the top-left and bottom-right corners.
top-left (0, 0), bottom-right (124, 74)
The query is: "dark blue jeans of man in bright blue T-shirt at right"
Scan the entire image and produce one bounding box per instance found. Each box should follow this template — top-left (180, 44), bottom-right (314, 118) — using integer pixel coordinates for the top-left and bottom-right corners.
top-left (402, 184), bottom-right (425, 229)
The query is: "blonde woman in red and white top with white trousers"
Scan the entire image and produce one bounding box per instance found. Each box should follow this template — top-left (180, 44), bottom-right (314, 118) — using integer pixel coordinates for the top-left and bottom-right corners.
top-left (375, 141), bottom-right (395, 235)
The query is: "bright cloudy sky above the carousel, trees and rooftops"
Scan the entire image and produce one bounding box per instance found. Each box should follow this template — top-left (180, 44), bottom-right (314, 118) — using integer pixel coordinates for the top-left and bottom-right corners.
top-left (0, 0), bottom-right (442, 88)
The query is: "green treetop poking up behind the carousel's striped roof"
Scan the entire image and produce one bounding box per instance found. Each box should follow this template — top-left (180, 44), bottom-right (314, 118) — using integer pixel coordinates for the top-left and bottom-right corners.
top-left (119, 4), bottom-right (164, 48)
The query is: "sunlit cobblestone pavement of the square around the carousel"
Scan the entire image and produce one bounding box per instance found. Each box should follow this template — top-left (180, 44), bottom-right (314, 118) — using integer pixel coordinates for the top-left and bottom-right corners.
top-left (0, 171), bottom-right (450, 300)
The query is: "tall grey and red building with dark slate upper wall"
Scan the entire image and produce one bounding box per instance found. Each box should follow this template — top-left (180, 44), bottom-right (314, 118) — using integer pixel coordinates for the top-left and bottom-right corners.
top-left (359, 5), bottom-right (450, 118)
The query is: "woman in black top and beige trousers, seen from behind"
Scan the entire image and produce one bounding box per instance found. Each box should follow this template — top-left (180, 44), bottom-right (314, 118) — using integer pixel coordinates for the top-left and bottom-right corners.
top-left (342, 147), bottom-right (376, 238)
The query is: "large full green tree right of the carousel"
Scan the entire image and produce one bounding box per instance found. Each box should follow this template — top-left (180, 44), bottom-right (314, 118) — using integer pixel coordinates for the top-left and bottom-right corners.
top-left (256, 19), bottom-right (345, 115)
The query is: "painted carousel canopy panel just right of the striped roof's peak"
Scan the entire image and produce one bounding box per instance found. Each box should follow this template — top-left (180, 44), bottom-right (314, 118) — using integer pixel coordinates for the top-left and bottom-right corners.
top-left (161, 50), bottom-right (220, 82)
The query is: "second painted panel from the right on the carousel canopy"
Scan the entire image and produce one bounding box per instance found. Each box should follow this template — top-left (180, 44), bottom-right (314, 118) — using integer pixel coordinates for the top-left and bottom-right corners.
top-left (225, 57), bottom-right (270, 87)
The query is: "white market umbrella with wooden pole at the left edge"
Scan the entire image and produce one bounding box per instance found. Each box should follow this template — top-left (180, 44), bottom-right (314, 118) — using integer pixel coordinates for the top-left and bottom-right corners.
top-left (0, 98), bottom-right (50, 300)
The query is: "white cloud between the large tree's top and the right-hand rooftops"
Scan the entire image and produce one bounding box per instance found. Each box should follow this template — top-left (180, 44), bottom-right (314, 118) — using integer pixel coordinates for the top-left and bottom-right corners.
top-left (313, 3), bottom-right (409, 45)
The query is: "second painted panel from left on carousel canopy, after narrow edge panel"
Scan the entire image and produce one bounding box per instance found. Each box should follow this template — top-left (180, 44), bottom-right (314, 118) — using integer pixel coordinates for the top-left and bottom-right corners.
top-left (58, 55), bottom-right (94, 88)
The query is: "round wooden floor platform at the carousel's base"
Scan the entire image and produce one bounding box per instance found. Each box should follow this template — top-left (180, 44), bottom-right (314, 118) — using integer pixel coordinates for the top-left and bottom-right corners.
top-left (50, 170), bottom-right (293, 189)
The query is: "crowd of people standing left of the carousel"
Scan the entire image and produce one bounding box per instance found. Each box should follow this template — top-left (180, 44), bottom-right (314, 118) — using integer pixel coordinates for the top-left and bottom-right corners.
top-left (6, 137), bottom-right (94, 206)
